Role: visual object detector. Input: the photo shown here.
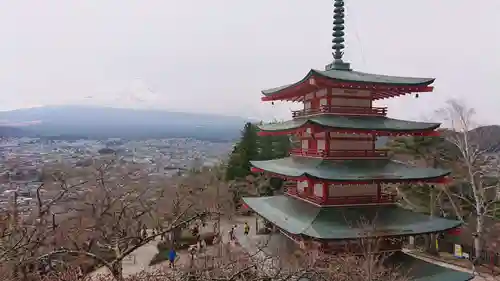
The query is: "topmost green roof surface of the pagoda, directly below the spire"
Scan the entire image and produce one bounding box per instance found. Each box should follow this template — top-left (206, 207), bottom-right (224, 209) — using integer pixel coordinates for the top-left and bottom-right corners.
top-left (262, 69), bottom-right (435, 96)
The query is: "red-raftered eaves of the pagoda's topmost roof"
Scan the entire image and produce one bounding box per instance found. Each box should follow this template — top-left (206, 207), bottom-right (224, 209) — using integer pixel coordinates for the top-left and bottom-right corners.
top-left (261, 70), bottom-right (434, 102)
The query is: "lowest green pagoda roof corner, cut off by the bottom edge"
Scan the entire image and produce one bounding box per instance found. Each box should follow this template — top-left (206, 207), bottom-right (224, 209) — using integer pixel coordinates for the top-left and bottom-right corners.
top-left (385, 252), bottom-right (474, 281)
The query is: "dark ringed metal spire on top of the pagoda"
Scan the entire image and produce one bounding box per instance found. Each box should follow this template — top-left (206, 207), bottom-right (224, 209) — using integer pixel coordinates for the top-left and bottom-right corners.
top-left (325, 0), bottom-right (351, 70)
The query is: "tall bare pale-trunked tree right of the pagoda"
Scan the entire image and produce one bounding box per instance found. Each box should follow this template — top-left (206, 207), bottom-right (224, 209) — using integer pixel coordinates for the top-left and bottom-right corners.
top-left (439, 100), bottom-right (500, 259)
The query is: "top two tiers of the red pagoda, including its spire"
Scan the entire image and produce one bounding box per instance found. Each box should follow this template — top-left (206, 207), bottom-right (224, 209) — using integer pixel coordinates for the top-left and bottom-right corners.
top-left (257, 0), bottom-right (440, 162)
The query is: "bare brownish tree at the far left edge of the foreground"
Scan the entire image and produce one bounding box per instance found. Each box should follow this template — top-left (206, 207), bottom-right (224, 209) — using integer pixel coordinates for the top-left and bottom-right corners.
top-left (0, 170), bottom-right (88, 280)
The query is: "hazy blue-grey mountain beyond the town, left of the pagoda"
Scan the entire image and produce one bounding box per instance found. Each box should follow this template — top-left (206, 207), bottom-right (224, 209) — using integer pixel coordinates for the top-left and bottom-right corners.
top-left (0, 105), bottom-right (252, 140)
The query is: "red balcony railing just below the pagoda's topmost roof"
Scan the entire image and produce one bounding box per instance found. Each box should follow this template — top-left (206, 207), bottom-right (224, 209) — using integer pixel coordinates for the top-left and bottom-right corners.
top-left (292, 105), bottom-right (387, 118)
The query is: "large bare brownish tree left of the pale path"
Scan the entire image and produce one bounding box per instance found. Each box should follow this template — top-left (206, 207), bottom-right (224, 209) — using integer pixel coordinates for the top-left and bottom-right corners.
top-left (29, 161), bottom-right (217, 280)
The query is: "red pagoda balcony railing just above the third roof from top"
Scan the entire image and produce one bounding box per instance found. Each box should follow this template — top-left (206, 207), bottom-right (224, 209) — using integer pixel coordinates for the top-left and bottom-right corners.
top-left (290, 148), bottom-right (388, 159)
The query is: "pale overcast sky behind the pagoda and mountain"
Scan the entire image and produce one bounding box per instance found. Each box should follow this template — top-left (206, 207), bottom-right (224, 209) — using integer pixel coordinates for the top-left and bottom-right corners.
top-left (0, 0), bottom-right (500, 124)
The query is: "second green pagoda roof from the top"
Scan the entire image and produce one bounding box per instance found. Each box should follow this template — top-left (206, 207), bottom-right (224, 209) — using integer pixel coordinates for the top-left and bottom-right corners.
top-left (259, 115), bottom-right (441, 133)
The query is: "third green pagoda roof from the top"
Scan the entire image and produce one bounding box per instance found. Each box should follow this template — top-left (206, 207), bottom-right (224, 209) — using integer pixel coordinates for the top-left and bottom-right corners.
top-left (250, 156), bottom-right (450, 182)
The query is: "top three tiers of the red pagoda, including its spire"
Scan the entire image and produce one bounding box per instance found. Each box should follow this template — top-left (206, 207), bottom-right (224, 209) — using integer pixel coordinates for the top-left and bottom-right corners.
top-left (251, 0), bottom-right (450, 207)
